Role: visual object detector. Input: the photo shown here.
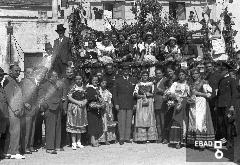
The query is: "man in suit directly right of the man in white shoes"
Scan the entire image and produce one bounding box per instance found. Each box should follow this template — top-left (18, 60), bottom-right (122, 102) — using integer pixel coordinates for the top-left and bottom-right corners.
top-left (21, 68), bottom-right (38, 154)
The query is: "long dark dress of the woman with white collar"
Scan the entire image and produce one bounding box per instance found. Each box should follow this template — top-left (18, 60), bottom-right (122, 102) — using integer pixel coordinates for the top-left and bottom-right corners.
top-left (86, 86), bottom-right (103, 139)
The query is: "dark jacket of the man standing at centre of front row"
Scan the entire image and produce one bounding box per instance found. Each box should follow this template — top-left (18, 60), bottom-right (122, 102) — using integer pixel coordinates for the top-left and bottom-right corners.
top-left (113, 76), bottom-right (137, 110)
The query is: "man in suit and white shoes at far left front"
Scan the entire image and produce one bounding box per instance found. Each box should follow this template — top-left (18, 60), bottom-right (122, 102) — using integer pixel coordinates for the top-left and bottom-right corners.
top-left (3, 64), bottom-right (25, 159)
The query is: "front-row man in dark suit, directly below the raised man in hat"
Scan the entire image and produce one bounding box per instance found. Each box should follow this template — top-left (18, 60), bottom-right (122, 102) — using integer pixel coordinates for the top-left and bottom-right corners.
top-left (39, 71), bottom-right (63, 154)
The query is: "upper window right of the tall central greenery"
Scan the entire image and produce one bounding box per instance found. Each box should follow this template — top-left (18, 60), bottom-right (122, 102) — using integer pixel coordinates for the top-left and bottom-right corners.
top-left (169, 2), bottom-right (186, 20)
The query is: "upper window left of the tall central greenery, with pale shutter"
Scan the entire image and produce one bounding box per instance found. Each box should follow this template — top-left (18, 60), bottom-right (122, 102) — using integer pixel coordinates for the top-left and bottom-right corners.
top-left (103, 2), bottom-right (125, 19)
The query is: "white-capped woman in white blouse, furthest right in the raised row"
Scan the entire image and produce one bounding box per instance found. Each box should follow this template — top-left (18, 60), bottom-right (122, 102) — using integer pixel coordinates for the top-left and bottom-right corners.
top-left (165, 37), bottom-right (182, 61)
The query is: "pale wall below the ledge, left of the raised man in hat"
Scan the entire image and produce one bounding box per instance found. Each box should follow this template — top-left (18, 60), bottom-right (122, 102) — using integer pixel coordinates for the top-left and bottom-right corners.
top-left (0, 19), bottom-right (68, 77)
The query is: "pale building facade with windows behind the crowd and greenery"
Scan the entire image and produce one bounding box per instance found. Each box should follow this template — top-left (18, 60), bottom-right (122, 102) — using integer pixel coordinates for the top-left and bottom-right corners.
top-left (0, 0), bottom-right (239, 77)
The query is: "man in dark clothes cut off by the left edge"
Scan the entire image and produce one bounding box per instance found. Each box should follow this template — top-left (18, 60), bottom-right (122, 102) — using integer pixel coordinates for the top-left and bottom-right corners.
top-left (0, 67), bottom-right (10, 158)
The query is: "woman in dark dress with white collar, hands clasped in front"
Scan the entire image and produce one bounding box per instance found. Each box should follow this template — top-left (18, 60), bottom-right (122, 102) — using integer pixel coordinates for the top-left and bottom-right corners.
top-left (86, 75), bottom-right (105, 147)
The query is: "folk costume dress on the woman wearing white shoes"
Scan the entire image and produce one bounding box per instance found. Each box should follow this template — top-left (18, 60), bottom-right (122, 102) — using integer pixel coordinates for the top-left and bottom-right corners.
top-left (66, 85), bottom-right (88, 133)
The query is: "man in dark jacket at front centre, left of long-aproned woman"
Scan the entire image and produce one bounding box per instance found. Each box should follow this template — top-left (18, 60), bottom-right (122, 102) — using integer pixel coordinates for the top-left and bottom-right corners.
top-left (113, 65), bottom-right (136, 145)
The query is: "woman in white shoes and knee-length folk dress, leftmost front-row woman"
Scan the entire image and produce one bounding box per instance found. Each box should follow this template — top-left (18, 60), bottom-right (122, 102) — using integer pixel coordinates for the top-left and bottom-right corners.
top-left (67, 75), bottom-right (88, 150)
